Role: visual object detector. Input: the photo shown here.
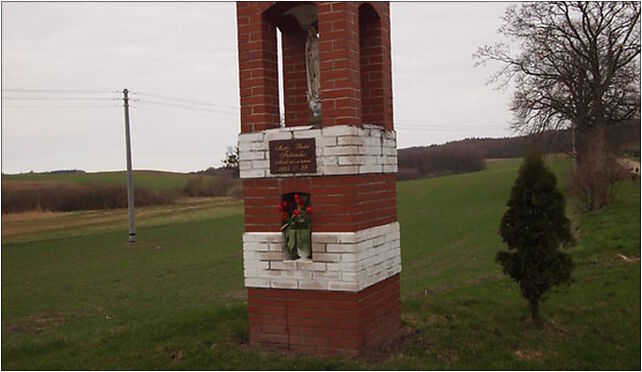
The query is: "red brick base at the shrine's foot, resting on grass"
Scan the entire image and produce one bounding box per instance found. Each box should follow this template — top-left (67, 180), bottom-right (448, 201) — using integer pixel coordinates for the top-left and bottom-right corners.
top-left (247, 274), bottom-right (401, 355)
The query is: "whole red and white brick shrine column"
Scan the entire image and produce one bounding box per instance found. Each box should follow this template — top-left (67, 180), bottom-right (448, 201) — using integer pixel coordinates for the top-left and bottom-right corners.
top-left (237, 2), bottom-right (401, 355)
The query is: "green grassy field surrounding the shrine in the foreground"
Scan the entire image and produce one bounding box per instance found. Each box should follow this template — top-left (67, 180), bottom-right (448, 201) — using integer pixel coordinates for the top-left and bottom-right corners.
top-left (1, 157), bottom-right (640, 370)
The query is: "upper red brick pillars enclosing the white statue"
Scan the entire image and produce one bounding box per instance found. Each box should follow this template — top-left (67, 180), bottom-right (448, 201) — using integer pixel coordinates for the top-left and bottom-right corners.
top-left (237, 2), bottom-right (393, 133)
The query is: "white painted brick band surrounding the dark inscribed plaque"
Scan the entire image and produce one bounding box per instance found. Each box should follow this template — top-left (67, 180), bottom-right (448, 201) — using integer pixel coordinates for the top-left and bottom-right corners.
top-left (238, 124), bottom-right (397, 178)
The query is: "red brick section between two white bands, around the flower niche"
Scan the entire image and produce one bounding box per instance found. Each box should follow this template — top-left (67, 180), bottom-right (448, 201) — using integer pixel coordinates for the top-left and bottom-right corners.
top-left (243, 174), bottom-right (397, 232)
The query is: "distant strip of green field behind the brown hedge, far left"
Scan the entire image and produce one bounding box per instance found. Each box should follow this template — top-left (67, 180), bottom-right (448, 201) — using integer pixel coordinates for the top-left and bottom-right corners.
top-left (2, 170), bottom-right (190, 191)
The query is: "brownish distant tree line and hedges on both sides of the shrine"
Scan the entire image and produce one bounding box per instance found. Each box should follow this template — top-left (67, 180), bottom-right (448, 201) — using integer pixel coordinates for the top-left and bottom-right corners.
top-left (2, 123), bottom-right (640, 213)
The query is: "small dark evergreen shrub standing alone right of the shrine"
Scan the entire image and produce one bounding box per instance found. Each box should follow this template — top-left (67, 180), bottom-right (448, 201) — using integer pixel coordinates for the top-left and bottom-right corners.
top-left (496, 152), bottom-right (575, 320)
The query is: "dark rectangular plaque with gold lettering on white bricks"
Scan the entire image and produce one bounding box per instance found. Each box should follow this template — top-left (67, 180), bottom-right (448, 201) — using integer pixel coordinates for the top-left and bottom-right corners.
top-left (270, 138), bottom-right (317, 174)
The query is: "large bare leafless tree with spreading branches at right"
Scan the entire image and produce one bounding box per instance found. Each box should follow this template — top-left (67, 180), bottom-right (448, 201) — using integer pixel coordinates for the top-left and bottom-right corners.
top-left (473, 2), bottom-right (640, 208)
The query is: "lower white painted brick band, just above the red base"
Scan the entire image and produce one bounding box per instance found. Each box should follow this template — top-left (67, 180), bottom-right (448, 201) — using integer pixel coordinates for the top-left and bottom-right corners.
top-left (243, 222), bottom-right (401, 292)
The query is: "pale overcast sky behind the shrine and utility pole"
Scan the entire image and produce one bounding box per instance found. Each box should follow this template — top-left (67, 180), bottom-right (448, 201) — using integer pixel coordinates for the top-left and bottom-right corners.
top-left (2, 2), bottom-right (512, 173)
